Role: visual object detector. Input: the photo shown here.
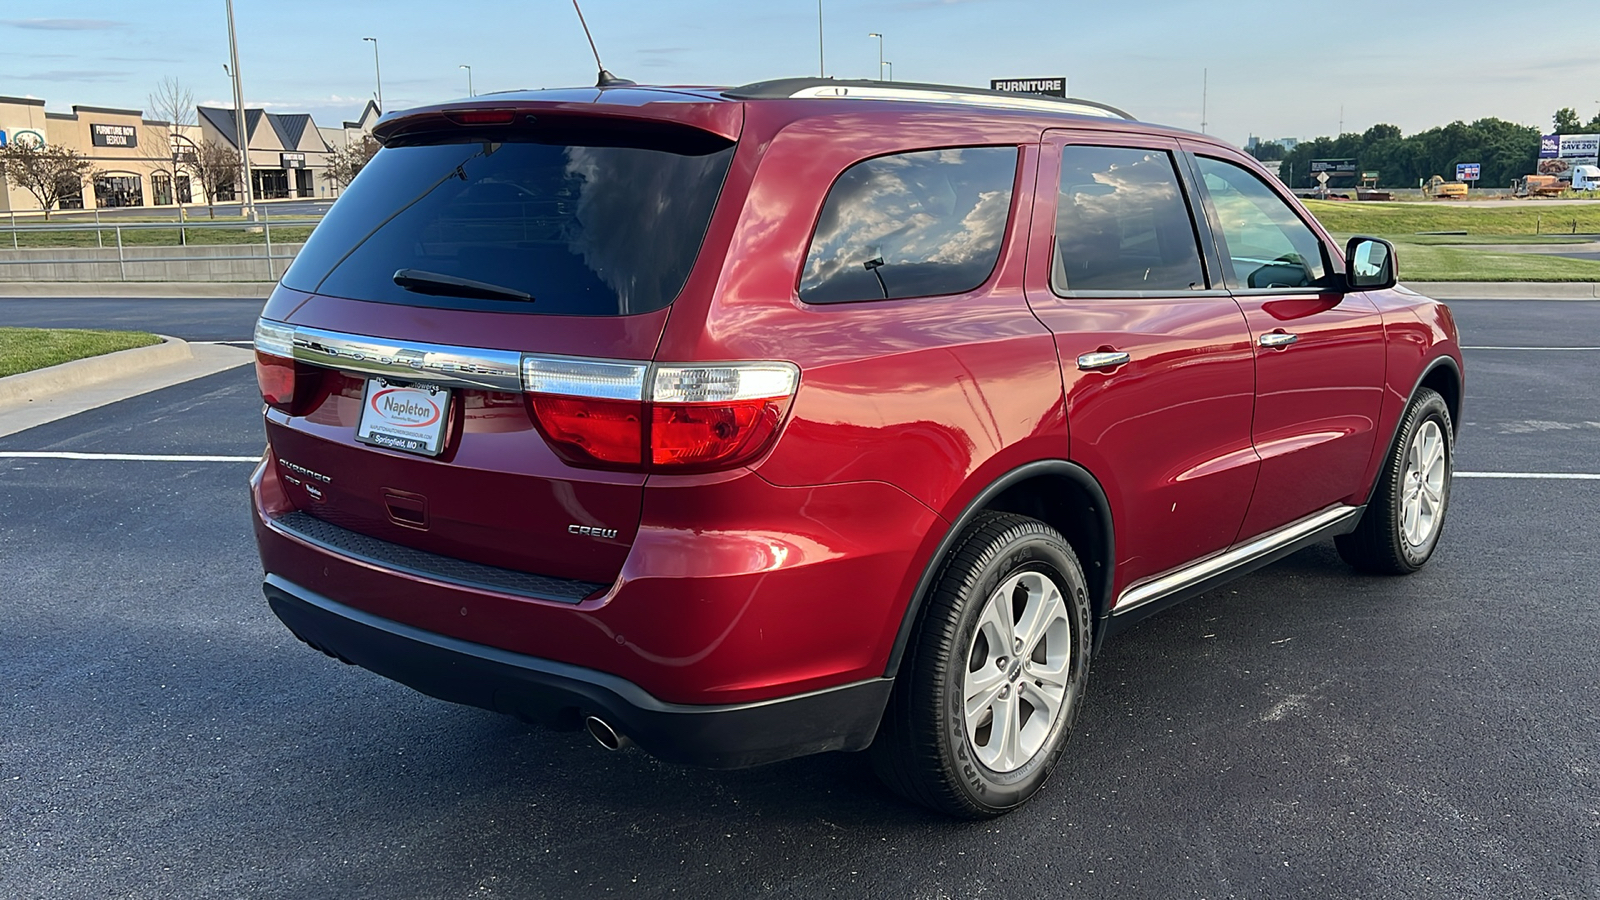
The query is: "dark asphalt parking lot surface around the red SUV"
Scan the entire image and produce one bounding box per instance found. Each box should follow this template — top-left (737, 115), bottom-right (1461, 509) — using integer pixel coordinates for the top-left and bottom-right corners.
top-left (0, 299), bottom-right (1600, 898)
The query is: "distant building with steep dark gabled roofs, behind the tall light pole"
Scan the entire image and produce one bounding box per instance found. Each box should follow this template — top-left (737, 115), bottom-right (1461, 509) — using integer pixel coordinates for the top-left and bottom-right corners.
top-left (197, 106), bottom-right (333, 200)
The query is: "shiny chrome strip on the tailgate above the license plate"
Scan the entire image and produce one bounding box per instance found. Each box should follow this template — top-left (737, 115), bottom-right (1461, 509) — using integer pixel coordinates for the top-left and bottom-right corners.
top-left (291, 325), bottom-right (522, 392)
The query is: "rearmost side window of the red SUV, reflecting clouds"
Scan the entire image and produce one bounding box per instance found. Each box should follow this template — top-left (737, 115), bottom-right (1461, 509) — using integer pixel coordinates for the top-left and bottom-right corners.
top-left (800, 147), bottom-right (1018, 303)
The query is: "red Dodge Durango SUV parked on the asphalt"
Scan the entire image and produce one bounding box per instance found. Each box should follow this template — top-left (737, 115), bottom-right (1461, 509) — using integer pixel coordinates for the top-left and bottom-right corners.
top-left (251, 78), bottom-right (1462, 817)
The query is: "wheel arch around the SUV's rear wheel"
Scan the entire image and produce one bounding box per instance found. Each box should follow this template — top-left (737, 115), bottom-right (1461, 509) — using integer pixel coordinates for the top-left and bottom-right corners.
top-left (883, 460), bottom-right (1115, 677)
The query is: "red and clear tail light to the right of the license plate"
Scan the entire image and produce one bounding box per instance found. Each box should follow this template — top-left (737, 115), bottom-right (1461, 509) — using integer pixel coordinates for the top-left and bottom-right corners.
top-left (522, 356), bottom-right (800, 472)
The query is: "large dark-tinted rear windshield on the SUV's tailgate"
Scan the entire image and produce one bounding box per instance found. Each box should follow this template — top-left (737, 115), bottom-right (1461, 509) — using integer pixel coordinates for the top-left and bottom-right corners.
top-left (283, 132), bottom-right (733, 315)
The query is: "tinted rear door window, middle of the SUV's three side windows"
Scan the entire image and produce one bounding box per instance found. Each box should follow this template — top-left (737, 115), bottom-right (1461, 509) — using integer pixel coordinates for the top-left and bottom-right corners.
top-left (1050, 146), bottom-right (1206, 295)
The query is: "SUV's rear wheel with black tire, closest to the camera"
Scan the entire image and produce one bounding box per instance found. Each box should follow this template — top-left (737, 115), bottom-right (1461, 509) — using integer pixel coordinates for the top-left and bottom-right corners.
top-left (872, 512), bottom-right (1091, 818)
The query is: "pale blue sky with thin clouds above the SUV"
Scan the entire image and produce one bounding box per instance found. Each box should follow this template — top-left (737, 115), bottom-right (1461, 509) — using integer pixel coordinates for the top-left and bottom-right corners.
top-left (0, 0), bottom-right (1600, 144)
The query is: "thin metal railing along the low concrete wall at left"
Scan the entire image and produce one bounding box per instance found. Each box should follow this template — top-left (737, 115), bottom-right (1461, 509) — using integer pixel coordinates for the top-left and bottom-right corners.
top-left (0, 216), bottom-right (322, 282)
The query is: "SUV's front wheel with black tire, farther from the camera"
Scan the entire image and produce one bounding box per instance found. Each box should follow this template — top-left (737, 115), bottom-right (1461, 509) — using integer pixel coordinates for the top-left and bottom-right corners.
top-left (1334, 381), bottom-right (1456, 575)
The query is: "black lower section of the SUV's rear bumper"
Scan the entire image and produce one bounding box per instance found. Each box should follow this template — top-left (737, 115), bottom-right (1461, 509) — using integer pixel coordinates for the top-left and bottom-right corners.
top-left (264, 575), bottom-right (893, 769)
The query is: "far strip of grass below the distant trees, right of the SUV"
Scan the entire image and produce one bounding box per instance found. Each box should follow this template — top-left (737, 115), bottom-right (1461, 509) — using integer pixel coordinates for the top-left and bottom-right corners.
top-left (1304, 200), bottom-right (1600, 235)
